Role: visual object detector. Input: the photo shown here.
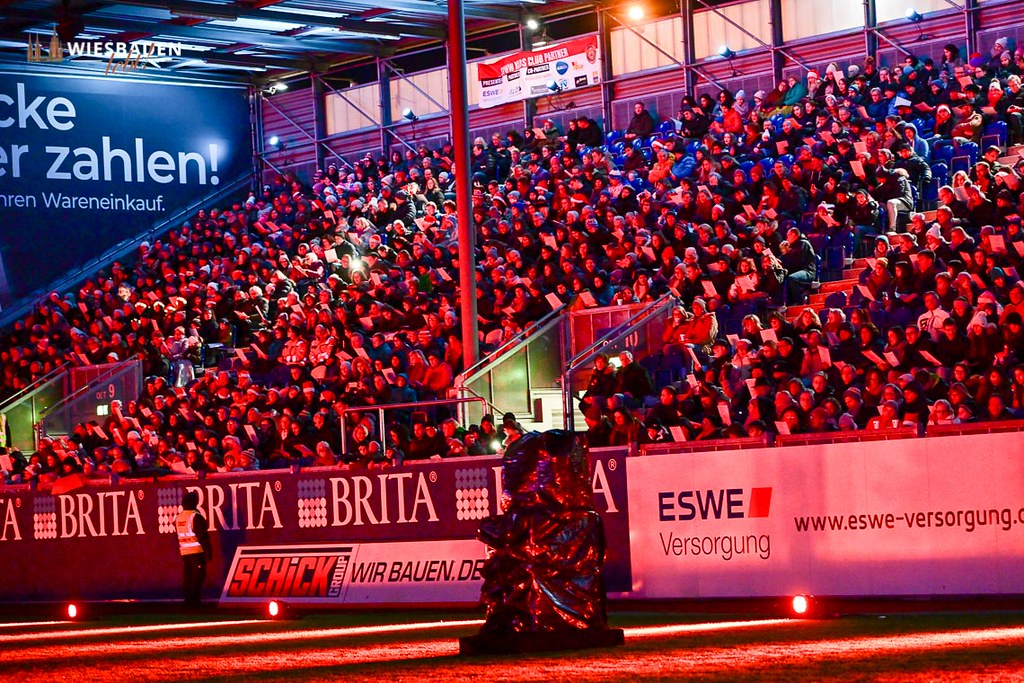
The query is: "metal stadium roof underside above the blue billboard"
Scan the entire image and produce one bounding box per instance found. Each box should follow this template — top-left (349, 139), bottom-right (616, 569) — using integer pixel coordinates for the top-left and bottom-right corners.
top-left (0, 0), bottom-right (581, 81)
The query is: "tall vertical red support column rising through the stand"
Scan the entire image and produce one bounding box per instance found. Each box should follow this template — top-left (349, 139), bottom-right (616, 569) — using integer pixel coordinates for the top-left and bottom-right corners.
top-left (447, 0), bottom-right (480, 368)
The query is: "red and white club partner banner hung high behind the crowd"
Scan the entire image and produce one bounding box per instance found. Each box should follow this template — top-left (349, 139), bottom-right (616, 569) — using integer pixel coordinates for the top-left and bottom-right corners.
top-left (472, 36), bottom-right (601, 109)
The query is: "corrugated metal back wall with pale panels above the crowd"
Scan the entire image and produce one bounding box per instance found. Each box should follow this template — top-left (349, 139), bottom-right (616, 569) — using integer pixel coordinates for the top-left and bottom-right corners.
top-left (263, 0), bottom-right (1024, 169)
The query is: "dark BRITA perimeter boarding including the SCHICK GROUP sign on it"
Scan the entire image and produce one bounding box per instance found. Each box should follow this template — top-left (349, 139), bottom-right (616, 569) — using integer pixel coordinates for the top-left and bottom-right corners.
top-left (0, 454), bottom-right (632, 604)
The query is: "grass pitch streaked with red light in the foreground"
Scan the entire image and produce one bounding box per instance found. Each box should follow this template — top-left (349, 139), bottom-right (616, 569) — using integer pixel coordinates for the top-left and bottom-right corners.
top-left (0, 612), bottom-right (1024, 683)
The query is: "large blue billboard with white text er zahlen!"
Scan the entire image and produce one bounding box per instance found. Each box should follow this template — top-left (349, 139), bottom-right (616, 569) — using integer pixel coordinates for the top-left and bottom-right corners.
top-left (0, 72), bottom-right (252, 303)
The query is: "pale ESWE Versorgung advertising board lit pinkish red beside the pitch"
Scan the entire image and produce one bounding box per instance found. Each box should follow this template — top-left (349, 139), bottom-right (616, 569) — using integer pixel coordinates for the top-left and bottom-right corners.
top-left (628, 433), bottom-right (1024, 598)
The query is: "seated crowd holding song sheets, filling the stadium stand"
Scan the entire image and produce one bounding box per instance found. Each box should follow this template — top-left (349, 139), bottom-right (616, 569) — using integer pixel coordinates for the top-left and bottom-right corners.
top-left (0, 39), bottom-right (1024, 481)
